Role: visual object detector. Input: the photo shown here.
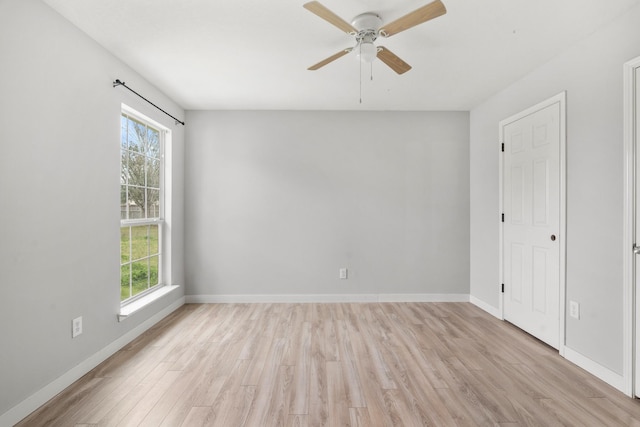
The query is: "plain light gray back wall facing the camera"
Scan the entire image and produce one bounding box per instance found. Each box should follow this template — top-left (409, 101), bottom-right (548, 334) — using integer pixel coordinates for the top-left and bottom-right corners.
top-left (185, 111), bottom-right (469, 295)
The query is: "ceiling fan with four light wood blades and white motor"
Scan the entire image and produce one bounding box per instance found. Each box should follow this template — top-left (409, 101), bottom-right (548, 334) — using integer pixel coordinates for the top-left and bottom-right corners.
top-left (303, 0), bottom-right (447, 74)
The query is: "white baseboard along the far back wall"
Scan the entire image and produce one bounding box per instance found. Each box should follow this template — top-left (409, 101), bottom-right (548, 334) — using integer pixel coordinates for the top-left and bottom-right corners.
top-left (185, 294), bottom-right (469, 304)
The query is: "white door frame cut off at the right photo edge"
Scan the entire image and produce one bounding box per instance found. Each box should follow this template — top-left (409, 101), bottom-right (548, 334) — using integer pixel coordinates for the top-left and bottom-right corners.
top-left (622, 57), bottom-right (640, 396)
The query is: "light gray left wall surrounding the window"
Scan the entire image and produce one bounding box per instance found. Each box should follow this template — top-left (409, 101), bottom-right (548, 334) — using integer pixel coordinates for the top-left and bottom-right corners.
top-left (0, 0), bottom-right (184, 415)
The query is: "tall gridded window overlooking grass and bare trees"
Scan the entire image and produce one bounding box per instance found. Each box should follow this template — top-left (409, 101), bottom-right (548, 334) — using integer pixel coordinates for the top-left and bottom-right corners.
top-left (120, 110), bottom-right (165, 304)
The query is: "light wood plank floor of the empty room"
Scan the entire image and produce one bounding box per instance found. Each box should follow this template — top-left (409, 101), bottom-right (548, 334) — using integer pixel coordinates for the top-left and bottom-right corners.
top-left (19, 303), bottom-right (640, 427)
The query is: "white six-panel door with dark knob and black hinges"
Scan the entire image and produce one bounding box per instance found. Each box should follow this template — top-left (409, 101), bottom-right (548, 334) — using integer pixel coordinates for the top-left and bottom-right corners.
top-left (500, 94), bottom-right (564, 348)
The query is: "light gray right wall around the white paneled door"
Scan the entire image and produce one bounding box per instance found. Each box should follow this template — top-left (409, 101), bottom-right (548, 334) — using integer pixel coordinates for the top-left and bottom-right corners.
top-left (470, 0), bottom-right (640, 374)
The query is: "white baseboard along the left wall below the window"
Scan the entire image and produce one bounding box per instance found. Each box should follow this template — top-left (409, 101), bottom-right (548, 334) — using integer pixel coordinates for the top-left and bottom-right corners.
top-left (0, 297), bottom-right (185, 427)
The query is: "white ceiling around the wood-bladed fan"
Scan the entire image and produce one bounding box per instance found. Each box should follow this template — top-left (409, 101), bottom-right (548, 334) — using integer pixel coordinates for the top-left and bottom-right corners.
top-left (43, 0), bottom-right (640, 110)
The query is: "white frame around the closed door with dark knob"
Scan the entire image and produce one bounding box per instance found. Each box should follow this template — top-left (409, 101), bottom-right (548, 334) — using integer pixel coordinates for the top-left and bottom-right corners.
top-left (498, 91), bottom-right (567, 357)
